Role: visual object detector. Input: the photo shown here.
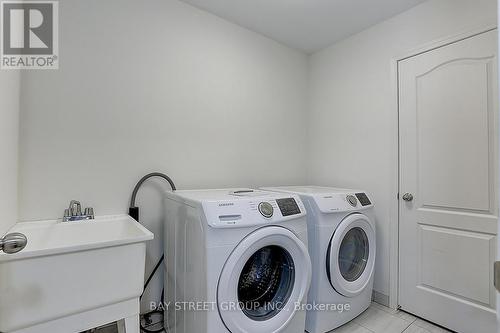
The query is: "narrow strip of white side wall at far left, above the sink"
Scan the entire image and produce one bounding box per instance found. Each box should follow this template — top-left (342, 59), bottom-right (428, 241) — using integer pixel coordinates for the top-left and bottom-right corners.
top-left (0, 70), bottom-right (20, 237)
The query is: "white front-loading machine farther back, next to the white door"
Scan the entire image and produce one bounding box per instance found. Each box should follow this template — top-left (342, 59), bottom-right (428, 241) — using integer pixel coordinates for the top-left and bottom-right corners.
top-left (265, 186), bottom-right (376, 333)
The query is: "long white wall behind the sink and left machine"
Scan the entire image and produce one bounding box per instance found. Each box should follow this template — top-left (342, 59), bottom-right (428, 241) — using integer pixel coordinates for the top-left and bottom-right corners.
top-left (19, 0), bottom-right (308, 310)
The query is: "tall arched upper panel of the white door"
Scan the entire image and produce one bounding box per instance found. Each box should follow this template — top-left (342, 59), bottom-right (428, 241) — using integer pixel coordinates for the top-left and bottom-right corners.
top-left (416, 57), bottom-right (494, 212)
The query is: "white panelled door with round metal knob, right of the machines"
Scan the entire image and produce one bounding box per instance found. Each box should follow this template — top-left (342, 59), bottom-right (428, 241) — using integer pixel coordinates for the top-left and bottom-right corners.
top-left (399, 30), bottom-right (498, 333)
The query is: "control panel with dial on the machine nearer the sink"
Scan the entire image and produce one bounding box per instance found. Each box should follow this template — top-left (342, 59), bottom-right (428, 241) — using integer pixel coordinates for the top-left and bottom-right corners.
top-left (202, 194), bottom-right (306, 228)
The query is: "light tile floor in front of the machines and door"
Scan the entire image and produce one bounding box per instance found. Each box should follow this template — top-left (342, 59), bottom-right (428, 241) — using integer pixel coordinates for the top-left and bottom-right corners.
top-left (95, 303), bottom-right (450, 333)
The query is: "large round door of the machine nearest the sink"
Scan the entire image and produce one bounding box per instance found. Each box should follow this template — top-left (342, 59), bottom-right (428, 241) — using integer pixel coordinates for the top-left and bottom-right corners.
top-left (217, 226), bottom-right (311, 333)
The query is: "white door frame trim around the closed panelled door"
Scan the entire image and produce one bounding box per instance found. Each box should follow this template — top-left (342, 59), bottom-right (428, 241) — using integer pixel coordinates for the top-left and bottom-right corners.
top-left (386, 22), bottom-right (497, 309)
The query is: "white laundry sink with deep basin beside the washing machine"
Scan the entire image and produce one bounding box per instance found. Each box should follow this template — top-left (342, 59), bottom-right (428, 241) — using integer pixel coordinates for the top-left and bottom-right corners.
top-left (0, 215), bottom-right (153, 333)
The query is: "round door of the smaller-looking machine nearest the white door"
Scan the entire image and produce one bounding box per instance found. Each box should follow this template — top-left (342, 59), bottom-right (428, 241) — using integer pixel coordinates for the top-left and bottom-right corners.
top-left (326, 213), bottom-right (376, 297)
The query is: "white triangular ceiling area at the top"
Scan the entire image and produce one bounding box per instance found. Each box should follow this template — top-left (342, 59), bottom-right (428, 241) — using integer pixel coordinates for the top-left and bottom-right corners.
top-left (182, 0), bottom-right (425, 53)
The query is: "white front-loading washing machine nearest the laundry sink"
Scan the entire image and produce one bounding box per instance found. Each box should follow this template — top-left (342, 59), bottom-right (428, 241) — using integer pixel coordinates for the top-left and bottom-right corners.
top-left (165, 189), bottom-right (311, 333)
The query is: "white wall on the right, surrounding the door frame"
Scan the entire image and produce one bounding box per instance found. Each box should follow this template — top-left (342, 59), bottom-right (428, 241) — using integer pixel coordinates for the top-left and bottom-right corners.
top-left (308, 0), bottom-right (496, 295)
